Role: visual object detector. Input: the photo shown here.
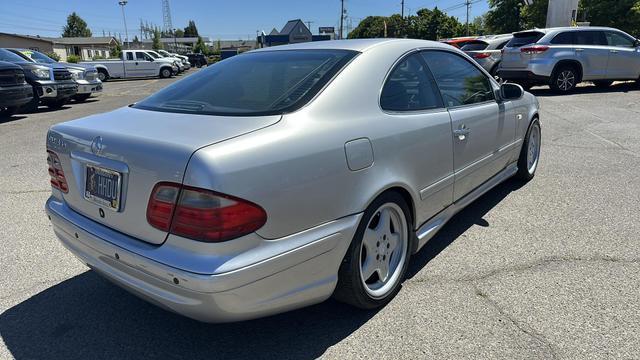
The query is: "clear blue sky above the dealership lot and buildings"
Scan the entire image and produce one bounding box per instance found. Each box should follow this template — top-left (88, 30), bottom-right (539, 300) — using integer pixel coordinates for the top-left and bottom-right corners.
top-left (0, 0), bottom-right (488, 40)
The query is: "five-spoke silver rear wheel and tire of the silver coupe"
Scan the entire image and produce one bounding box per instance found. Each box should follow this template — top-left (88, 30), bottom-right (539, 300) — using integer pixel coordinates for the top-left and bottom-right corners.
top-left (334, 192), bottom-right (415, 309)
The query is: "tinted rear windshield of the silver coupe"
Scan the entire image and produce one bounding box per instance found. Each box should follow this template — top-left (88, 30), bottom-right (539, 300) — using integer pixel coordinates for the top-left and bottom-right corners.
top-left (134, 50), bottom-right (357, 116)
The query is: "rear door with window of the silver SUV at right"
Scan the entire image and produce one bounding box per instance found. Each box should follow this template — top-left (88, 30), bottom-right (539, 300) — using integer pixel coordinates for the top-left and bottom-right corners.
top-left (575, 30), bottom-right (609, 80)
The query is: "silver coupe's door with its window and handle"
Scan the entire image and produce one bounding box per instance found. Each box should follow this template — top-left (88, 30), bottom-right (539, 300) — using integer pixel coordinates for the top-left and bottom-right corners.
top-left (423, 50), bottom-right (516, 201)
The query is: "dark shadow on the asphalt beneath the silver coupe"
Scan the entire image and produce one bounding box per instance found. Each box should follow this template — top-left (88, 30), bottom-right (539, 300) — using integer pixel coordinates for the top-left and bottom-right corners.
top-left (0, 180), bottom-right (523, 359)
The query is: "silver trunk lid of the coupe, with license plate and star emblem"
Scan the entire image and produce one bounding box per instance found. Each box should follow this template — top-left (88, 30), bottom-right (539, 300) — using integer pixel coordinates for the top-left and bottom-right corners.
top-left (47, 107), bottom-right (280, 244)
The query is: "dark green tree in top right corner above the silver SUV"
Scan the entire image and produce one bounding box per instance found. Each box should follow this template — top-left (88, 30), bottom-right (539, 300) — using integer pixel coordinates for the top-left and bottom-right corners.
top-left (580, 0), bottom-right (640, 37)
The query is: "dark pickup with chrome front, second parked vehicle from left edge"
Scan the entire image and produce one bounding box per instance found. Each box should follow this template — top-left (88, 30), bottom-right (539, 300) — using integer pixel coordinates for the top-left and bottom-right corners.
top-left (0, 49), bottom-right (78, 112)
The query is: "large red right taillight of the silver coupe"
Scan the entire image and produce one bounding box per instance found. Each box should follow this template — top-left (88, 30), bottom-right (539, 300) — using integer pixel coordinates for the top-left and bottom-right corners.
top-left (147, 183), bottom-right (267, 242)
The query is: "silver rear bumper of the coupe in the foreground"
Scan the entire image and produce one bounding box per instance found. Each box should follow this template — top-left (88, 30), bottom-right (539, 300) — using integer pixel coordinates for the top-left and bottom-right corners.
top-left (45, 197), bottom-right (361, 322)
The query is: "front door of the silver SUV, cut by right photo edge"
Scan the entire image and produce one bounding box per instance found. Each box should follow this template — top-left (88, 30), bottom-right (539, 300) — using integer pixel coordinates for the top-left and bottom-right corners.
top-left (605, 31), bottom-right (640, 80)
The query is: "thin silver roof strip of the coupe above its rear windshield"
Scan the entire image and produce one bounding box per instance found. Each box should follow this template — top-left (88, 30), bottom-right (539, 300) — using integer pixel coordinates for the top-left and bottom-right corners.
top-left (251, 38), bottom-right (451, 52)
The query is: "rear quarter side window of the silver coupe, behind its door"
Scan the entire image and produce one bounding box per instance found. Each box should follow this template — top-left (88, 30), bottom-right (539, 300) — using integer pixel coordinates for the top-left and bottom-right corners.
top-left (380, 54), bottom-right (442, 111)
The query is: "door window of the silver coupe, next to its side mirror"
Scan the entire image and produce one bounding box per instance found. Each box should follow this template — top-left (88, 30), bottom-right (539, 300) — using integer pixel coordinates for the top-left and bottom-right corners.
top-left (422, 51), bottom-right (495, 107)
